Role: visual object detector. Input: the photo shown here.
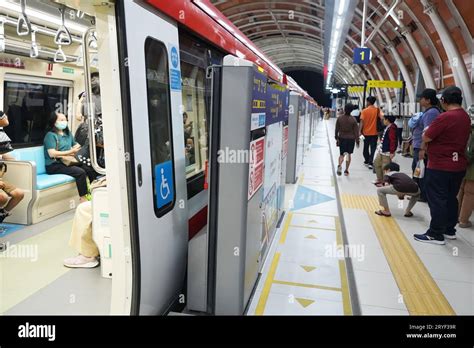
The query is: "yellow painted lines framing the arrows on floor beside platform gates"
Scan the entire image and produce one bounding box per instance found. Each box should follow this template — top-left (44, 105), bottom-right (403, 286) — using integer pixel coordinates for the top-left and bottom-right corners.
top-left (255, 212), bottom-right (352, 315)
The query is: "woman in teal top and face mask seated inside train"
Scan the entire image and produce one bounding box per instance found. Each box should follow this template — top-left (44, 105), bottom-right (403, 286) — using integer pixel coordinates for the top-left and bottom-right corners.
top-left (44, 112), bottom-right (97, 203)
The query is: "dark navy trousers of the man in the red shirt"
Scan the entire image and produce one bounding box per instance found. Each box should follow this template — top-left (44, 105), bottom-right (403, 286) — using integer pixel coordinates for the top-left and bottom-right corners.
top-left (424, 169), bottom-right (466, 239)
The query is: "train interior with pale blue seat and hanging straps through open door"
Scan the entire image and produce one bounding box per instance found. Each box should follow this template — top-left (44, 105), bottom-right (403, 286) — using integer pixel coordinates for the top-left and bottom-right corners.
top-left (0, 0), bottom-right (112, 315)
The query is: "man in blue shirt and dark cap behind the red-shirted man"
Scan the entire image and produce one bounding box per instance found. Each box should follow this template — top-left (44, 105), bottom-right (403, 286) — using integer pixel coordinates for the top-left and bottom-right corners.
top-left (408, 88), bottom-right (440, 202)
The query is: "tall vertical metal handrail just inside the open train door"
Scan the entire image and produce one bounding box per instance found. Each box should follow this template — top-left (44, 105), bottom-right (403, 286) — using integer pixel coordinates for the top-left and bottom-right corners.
top-left (82, 28), bottom-right (105, 175)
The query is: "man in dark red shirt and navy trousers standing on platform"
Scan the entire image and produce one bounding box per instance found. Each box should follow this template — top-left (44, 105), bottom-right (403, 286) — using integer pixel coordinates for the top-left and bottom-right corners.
top-left (414, 86), bottom-right (471, 244)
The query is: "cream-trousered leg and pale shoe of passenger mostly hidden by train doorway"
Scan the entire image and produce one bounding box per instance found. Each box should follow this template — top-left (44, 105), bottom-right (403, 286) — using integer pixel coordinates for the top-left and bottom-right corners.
top-left (64, 178), bottom-right (106, 268)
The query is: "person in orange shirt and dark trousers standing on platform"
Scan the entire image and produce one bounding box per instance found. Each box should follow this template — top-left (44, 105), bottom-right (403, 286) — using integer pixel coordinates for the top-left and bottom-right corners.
top-left (359, 96), bottom-right (381, 169)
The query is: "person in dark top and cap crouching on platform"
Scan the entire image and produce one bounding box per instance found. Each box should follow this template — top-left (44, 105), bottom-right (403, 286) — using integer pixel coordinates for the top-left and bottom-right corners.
top-left (375, 162), bottom-right (420, 217)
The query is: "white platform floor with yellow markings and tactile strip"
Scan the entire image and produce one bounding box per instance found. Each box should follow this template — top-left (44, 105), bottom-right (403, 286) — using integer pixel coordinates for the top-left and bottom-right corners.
top-left (247, 119), bottom-right (474, 315)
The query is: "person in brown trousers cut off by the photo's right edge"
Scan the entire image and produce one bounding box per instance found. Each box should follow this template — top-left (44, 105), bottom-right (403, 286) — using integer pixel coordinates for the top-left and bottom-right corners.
top-left (458, 126), bottom-right (474, 228)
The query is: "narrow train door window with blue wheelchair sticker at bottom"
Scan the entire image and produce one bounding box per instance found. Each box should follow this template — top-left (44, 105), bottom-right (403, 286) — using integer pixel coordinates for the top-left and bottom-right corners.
top-left (145, 38), bottom-right (175, 217)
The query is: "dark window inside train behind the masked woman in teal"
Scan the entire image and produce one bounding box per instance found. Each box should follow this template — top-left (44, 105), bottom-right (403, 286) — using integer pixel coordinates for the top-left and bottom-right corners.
top-left (3, 78), bottom-right (69, 148)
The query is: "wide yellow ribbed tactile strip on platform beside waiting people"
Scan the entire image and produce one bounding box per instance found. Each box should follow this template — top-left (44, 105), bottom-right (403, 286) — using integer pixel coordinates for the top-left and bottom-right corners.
top-left (341, 194), bottom-right (456, 315)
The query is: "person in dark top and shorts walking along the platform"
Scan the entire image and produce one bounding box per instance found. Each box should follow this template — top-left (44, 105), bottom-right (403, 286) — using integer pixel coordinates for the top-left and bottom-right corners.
top-left (335, 104), bottom-right (359, 176)
